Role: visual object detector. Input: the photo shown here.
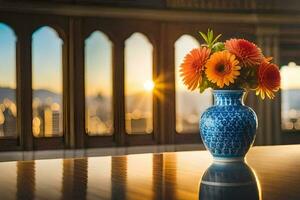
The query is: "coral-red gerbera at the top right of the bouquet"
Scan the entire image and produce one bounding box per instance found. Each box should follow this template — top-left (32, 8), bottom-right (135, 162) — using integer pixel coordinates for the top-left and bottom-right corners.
top-left (225, 39), bottom-right (263, 67)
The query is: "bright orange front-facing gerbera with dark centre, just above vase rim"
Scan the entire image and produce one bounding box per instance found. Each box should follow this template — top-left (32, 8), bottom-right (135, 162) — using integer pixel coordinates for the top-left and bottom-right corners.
top-left (205, 51), bottom-right (241, 88)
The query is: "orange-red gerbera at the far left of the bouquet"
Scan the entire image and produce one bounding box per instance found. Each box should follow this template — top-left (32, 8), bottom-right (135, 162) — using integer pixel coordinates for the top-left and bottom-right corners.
top-left (180, 47), bottom-right (210, 90)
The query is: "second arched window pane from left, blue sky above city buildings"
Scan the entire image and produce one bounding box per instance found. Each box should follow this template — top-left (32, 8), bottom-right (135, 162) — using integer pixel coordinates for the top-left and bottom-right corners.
top-left (32, 27), bottom-right (63, 137)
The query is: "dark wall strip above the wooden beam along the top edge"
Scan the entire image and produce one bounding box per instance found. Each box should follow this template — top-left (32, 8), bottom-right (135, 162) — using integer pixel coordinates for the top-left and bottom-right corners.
top-left (0, 0), bottom-right (300, 14)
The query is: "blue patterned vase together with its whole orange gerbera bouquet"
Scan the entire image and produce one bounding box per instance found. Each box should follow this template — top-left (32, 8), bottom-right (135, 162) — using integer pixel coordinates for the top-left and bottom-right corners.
top-left (180, 30), bottom-right (280, 161)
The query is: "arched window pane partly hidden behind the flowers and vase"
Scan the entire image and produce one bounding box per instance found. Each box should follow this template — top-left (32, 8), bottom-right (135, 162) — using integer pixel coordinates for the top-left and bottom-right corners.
top-left (175, 35), bottom-right (212, 133)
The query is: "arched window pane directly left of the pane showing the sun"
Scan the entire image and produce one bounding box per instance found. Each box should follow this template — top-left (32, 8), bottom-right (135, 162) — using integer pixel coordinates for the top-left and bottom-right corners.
top-left (85, 31), bottom-right (113, 135)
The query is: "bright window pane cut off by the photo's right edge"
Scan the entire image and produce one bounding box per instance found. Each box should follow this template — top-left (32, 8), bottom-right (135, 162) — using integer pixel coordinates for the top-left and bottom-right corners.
top-left (281, 62), bottom-right (300, 130)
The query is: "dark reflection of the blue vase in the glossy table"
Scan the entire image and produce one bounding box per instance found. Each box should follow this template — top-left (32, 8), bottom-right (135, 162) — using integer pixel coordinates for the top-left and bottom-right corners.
top-left (199, 162), bottom-right (262, 200)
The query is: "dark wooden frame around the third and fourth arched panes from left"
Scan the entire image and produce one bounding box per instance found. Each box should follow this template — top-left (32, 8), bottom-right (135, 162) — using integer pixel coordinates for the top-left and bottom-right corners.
top-left (81, 18), bottom-right (157, 147)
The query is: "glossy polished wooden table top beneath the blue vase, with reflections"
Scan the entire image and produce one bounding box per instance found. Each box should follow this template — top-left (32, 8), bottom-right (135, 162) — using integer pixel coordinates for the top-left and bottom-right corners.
top-left (0, 145), bottom-right (300, 200)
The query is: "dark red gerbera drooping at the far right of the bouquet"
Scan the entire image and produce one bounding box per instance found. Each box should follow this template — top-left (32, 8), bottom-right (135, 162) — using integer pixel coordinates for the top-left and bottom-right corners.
top-left (256, 60), bottom-right (280, 99)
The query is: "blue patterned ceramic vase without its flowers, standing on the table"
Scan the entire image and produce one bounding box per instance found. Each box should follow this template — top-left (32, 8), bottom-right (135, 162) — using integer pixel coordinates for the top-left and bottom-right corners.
top-left (199, 90), bottom-right (257, 162)
